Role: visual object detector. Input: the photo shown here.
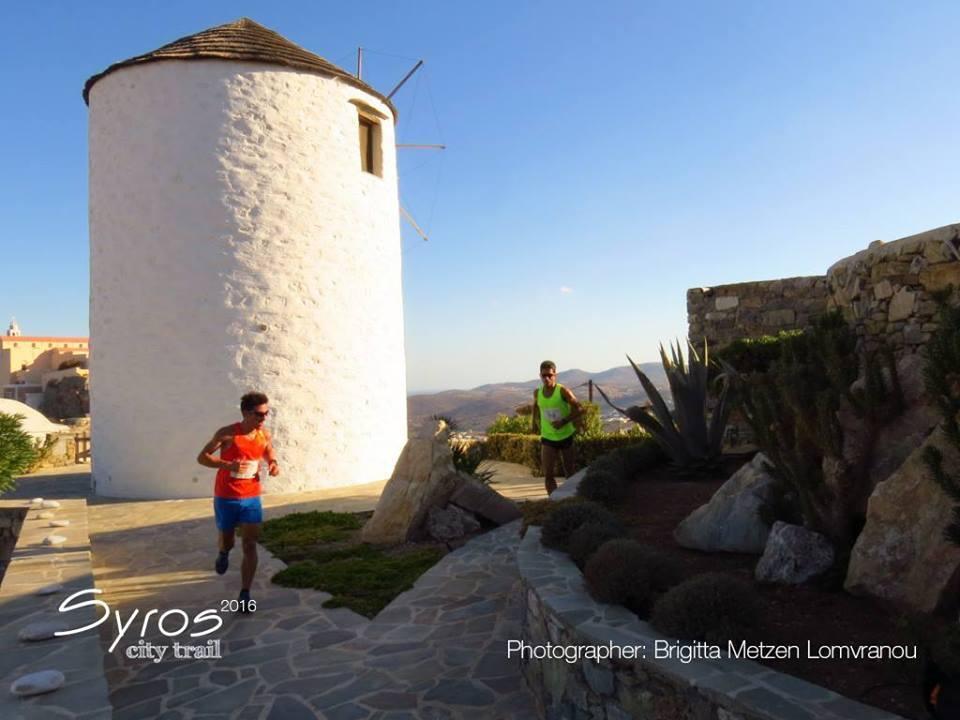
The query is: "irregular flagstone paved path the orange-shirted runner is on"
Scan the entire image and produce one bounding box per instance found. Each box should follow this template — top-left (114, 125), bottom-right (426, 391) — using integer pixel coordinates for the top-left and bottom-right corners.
top-left (7, 464), bottom-right (542, 720)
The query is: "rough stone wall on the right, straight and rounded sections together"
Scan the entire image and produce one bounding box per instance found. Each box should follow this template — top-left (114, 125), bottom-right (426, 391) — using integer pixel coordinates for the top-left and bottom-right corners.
top-left (687, 224), bottom-right (960, 355)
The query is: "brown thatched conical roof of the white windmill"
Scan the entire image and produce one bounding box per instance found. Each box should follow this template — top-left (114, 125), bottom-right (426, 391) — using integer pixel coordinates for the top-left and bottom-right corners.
top-left (83, 18), bottom-right (397, 120)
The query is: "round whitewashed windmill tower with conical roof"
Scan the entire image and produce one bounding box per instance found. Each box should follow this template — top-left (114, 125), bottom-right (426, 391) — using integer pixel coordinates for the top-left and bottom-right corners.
top-left (83, 19), bottom-right (407, 498)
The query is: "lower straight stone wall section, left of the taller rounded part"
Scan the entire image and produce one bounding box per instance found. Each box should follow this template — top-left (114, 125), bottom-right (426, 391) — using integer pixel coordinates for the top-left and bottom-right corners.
top-left (687, 276), bottom-right (827, 347)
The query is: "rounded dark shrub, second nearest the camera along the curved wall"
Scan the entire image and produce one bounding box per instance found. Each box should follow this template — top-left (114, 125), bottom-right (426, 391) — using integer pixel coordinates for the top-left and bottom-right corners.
top-left (583, 540), bottom-right (681, 617)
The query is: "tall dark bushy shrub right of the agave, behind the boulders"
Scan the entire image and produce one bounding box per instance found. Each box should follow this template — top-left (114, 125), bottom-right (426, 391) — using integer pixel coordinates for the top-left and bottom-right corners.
top-left (740, 313), bottom-right (903, 554)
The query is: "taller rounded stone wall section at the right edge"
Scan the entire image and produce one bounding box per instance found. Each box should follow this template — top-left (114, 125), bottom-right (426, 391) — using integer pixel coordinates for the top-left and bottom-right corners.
top-left (827, 224), bottom-right (960, 355)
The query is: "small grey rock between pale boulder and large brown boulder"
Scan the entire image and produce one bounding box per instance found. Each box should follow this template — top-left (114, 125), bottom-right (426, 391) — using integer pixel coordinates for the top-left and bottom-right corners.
top-left (754, 520), bottom-right (833, 585)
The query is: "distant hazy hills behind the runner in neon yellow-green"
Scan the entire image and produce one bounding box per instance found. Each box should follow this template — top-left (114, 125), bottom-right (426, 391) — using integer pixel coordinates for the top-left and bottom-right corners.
top-left (407, 363), bottom-right (669, 432)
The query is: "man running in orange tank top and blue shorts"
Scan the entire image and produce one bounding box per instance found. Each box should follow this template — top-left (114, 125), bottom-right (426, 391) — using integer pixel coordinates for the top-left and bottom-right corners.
top-left (197, 393), bottom-right (280, 612)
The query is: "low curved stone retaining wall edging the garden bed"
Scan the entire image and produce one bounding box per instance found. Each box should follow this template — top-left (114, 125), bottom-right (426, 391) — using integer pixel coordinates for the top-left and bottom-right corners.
top-left (517, 474), bottom-right (902, 720)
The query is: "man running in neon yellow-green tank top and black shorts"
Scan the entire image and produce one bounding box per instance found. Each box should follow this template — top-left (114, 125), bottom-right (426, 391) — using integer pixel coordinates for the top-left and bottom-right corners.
top-left (533, 360), bottom-right (583, 495)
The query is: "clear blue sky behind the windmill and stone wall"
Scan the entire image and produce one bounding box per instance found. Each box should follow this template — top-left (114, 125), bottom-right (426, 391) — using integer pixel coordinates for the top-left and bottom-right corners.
top-left (0, 1), bottom-right (960, 390)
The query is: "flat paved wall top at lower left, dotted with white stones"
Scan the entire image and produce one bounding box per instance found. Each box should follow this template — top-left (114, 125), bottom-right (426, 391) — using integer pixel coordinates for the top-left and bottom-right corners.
top-left (0, 500), bottom-right (113, 720)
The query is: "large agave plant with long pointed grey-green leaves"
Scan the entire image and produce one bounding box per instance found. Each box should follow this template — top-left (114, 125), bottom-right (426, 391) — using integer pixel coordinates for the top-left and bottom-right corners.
top-left (594, 340), bottom-right (732, 472)
